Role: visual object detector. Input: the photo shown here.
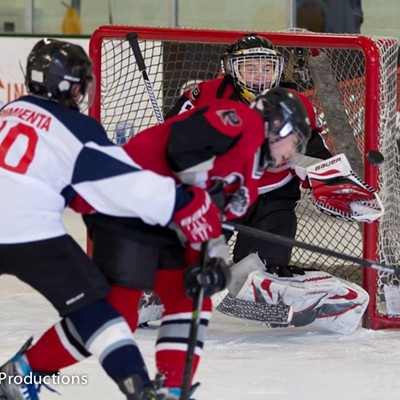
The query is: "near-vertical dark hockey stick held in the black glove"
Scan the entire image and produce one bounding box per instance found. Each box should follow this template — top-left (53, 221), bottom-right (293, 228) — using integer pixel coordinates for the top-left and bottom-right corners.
top-left (179, 241), bottom-right (208, 400)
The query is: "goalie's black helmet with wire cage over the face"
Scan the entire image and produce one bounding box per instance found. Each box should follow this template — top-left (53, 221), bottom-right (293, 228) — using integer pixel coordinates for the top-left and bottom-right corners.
top-left (221, 33), bottom-right (285, 103)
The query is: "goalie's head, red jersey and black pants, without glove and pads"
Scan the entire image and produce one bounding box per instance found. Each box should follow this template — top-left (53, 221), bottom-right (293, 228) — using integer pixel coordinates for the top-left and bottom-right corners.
top-left (166, 34), bottom-right (331, 269)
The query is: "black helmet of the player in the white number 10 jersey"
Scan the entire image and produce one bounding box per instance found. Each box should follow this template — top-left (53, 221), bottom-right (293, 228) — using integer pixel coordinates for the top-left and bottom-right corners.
top-left (25, 38), bottom-right (93, 108)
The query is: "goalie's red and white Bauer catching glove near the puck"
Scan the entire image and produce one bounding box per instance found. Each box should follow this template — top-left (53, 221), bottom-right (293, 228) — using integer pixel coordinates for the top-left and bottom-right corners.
top-left (307, 154), bottom-right (384, 222)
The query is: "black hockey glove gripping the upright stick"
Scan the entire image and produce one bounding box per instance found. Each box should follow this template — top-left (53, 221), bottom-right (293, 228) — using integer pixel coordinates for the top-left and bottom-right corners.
top-left (184, 257), bottom-right (231, 299)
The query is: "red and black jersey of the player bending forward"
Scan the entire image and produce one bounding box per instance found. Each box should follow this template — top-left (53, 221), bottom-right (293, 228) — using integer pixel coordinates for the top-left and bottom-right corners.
top-left (124, 100), bottom-right (265, 219)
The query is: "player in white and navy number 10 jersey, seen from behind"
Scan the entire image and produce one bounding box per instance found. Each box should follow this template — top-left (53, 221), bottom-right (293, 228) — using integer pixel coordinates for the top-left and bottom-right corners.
top-left (0, 39), bottom-right (221, 400)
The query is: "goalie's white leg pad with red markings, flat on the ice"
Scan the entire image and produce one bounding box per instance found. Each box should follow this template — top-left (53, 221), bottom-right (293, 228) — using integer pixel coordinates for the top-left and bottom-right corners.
top-left (236, 271), bottom-right (369, 334)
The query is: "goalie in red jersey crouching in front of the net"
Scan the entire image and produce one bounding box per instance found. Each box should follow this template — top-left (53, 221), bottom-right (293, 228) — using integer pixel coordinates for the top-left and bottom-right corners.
top-left (148, 34), bottom-right (382, 333)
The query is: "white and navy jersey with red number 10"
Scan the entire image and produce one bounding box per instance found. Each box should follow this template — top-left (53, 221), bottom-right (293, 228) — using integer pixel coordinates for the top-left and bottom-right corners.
top-left (0, 96), bottom-right (177, 244)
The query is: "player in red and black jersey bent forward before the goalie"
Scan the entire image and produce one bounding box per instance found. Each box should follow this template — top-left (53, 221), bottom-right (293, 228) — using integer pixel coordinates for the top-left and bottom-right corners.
top-left (18, 89), bottom-right (310, 400)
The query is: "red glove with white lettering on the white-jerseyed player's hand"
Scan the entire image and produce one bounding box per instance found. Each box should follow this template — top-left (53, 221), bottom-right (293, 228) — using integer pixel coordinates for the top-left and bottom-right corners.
top-left (173, 187), bottom-right (222, 243)
